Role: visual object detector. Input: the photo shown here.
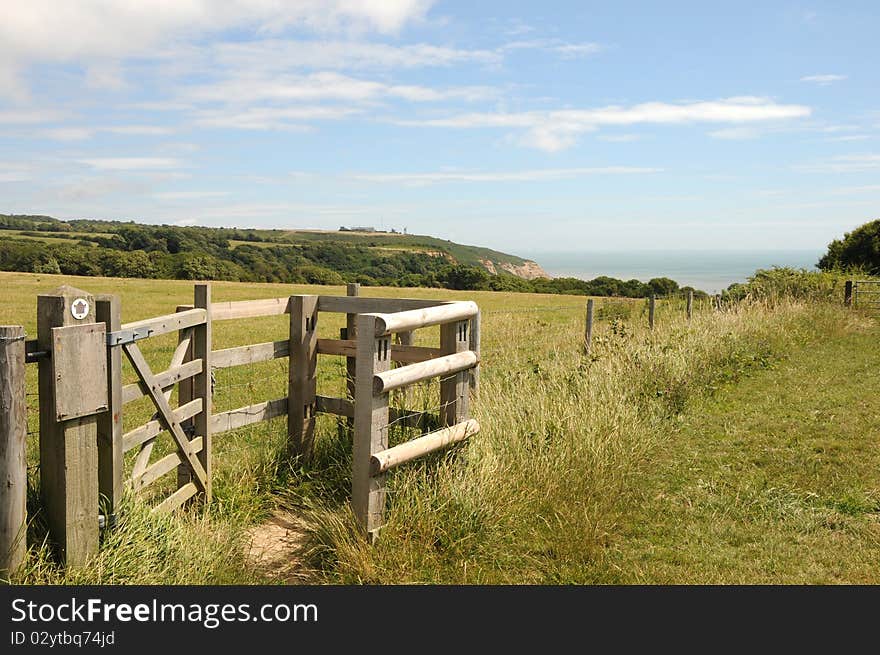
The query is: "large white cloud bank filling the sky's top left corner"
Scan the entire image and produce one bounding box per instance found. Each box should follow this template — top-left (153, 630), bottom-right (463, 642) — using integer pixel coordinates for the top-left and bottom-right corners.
top-left (0, 0), bottom-right (433, 98)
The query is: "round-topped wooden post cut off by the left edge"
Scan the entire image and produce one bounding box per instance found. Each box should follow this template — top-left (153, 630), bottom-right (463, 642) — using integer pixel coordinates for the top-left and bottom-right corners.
top-left (0, 325), bottom-right (27, 578)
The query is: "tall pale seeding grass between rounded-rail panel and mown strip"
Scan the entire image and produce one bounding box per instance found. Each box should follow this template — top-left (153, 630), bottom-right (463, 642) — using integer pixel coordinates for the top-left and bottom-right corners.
top-left (298, 297), bottom-right (850, 583)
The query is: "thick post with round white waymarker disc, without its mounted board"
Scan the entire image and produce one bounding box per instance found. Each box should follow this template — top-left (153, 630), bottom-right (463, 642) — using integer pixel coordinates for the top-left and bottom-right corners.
top-left (37, 285), bottom-right (104, 566)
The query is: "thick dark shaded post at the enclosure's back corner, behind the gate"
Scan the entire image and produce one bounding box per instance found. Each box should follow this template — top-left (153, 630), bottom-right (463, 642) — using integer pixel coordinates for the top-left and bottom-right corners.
top-left (287, 296), bottom-right (318, 459)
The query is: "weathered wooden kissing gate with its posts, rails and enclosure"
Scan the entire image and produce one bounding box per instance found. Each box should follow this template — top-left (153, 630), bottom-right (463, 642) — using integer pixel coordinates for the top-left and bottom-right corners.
top-left (0, 284), bottom-right (480, 571)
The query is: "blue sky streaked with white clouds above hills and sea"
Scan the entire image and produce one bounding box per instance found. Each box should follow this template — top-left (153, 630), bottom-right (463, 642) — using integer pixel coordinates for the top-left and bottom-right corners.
top-left (0, 0), bottom-right (880, 252)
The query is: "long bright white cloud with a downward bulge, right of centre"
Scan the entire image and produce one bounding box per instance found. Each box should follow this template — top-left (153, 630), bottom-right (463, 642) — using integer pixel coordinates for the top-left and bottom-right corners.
top-left (397, 96), bottom-right (810, 152)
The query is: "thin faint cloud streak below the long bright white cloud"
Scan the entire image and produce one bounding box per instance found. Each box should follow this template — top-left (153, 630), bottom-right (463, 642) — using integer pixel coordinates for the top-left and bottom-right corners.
top-left (350, 166), bottom-right (663, 186)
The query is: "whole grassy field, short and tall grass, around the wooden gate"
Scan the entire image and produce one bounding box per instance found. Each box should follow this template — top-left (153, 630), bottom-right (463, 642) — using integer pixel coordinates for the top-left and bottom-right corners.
top-left (0, 273), bottom-right (880, 584)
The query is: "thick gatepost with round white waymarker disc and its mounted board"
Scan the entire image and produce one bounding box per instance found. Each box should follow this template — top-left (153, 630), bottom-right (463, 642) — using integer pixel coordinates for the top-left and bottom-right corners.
top-left (37, 286), bottom-right (101, 567)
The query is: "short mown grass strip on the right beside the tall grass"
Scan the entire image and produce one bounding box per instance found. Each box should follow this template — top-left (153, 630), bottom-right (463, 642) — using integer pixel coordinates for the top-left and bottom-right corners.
top-left (592, 320), bottom-right (880, 584)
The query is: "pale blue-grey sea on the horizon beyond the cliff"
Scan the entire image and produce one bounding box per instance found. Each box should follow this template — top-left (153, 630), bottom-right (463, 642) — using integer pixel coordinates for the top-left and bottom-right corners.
top-left (517, 249), bottom-right (824, 293)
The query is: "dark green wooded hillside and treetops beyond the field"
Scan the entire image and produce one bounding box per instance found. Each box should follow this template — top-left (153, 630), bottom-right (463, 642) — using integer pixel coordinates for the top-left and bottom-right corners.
top-left (0, 215), bottom-right (696, 298)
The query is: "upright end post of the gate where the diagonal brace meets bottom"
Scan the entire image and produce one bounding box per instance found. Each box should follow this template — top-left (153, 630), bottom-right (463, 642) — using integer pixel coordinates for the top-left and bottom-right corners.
top-left (192, 283), bottom-right (214, 503)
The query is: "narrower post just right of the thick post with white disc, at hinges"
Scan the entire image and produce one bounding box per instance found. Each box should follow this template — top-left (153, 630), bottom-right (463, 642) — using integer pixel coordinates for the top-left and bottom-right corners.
top-left (95, 295), bottom-right (124, 526)
